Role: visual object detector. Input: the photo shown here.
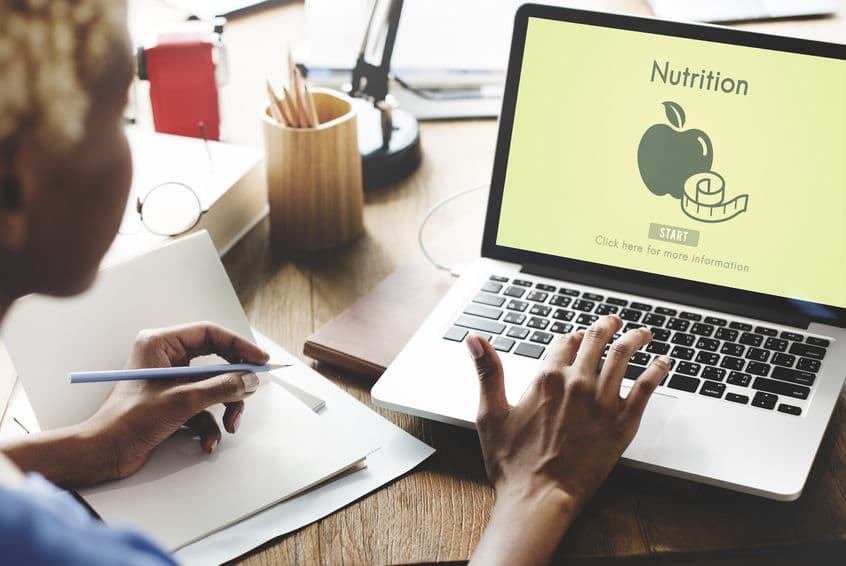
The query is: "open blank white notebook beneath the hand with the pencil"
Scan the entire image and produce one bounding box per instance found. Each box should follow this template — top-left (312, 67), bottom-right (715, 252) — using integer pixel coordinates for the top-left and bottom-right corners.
top-left (3, 232), bottom-right (379, 550)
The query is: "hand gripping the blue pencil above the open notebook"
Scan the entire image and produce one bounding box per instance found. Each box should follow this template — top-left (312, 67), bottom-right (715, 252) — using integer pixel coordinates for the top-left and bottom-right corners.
top-left (87, 323), bottom-right (268, 484)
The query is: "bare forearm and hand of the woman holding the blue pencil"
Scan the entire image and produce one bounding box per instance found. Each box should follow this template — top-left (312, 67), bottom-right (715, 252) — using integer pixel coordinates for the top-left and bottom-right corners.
top-left (0, 323), bottom-right (268, 488)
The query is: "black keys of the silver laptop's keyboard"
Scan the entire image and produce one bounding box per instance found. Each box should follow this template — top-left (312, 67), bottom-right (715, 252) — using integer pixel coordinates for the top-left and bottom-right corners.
top-left (443, 275), bottom-right (831, 416)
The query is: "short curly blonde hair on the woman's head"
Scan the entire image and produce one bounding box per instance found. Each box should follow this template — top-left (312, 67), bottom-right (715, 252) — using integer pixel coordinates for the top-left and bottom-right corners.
top-left (0, 0), bottom-right (126, 151)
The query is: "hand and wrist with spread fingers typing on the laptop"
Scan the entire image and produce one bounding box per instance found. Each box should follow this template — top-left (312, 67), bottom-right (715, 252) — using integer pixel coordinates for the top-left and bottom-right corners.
top-left (467, 316), bottom-right (670, 563)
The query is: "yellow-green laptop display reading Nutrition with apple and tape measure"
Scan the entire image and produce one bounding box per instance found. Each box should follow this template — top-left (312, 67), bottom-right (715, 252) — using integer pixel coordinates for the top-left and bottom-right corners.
top-left (495, 17), bottom-right (846, 308)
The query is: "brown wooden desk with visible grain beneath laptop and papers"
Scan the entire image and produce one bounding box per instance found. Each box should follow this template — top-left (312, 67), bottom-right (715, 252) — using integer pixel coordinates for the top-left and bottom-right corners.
top-left (164, 0), bottom-right (846, 564)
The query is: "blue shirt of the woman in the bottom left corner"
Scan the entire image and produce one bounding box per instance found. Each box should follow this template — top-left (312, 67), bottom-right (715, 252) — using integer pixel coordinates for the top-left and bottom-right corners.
top-left (0, 474), bottom-right (176, 566)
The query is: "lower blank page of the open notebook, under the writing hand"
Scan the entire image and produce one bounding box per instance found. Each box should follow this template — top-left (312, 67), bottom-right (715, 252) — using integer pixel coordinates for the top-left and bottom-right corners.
top-left (79, 382), bottom-right (372, 550)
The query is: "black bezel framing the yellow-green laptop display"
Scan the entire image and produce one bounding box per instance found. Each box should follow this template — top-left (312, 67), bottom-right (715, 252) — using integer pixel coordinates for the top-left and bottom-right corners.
top-left (482, 4), bottom-right (846, 327)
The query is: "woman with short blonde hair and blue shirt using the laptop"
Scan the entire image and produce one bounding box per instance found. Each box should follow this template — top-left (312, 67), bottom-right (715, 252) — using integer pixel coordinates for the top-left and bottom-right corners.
top-left (0, 0), bottom-right (669, 564)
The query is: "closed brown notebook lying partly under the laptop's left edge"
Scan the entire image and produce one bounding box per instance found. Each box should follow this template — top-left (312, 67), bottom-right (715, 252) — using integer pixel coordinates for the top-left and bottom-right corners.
top-left (303, 260), bottom-right (455, 378)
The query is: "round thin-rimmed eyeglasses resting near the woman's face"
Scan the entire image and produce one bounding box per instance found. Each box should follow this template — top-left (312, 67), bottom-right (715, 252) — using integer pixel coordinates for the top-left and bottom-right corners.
top-left (118, 182), bottom-right (208, 236)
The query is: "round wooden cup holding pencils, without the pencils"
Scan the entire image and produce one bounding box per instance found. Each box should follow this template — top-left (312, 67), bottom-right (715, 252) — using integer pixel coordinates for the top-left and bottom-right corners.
top-left (262, 88), bottom-right (364, 251)
